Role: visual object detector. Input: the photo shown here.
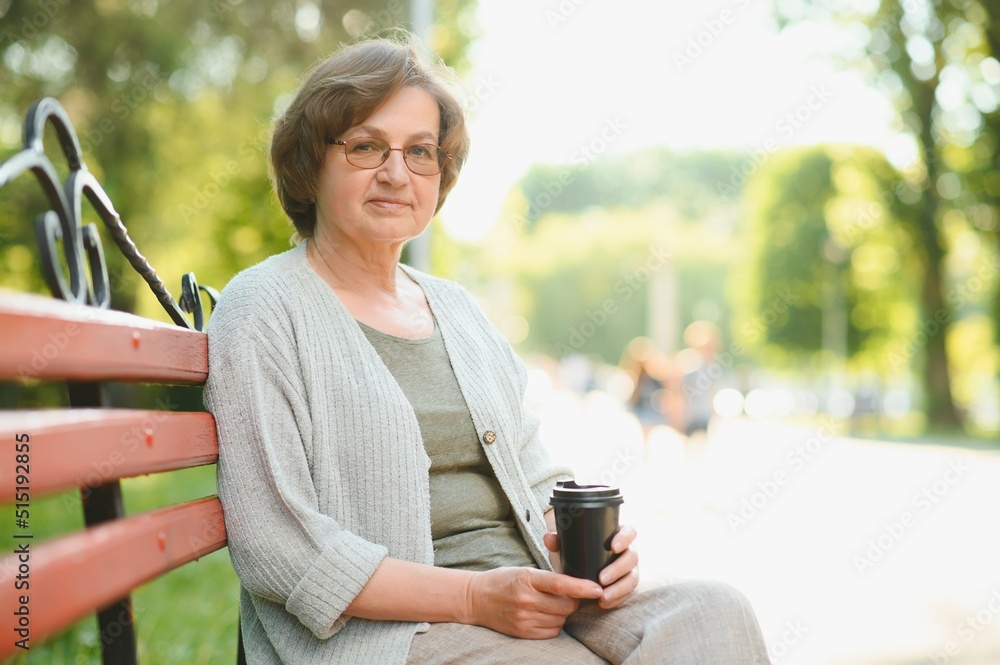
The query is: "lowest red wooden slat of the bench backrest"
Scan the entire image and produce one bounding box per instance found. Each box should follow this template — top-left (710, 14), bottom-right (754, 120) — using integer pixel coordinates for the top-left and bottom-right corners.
top-left (0, 497), bottom-right (226, 657)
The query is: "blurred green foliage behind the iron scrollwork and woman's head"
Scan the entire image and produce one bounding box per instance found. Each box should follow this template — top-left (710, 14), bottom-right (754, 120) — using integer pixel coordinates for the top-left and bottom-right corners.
top-left (0, 0), bottom-right (476, 318)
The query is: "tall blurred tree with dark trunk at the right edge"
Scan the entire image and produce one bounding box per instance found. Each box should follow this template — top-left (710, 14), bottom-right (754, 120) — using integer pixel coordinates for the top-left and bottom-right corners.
top-left (777, 0), bottom-right (1000, 427)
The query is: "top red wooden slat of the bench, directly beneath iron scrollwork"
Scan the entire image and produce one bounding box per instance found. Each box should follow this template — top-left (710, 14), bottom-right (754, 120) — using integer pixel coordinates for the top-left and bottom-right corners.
top-left (0, 291), bottom-right (208, 384)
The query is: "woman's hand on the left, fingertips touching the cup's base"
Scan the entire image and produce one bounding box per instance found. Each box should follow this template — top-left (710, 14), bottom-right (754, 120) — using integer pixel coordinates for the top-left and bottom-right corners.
top-left (465, 568), bottom-right (604, 640)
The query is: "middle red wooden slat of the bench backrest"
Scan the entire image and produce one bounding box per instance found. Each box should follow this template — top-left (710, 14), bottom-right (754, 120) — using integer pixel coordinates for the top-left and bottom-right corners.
top-left (0, 409), bottom-right (219, 502)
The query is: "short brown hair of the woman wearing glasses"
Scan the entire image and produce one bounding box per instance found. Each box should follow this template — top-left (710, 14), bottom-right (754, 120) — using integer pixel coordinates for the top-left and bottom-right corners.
top-left (271, 38), bottom-right (469, 238)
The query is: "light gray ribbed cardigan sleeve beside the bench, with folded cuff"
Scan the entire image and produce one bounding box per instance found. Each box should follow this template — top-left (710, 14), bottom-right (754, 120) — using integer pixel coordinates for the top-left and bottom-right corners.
top-left (205, 288), bottom-right (387, 639)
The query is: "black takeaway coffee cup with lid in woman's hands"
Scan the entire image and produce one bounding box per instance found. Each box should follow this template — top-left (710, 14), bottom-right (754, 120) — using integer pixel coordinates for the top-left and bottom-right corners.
top-left (549, 480), bottom-right (625, 584)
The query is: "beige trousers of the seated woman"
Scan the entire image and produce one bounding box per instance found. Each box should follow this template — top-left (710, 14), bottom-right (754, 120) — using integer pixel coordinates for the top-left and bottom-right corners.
top-left (406, 582), bottom-right (770, 665)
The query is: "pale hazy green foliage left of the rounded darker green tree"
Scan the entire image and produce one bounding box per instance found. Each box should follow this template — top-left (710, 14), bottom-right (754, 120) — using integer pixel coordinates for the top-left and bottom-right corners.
top-left (483, 149), bottom-right (742, 364)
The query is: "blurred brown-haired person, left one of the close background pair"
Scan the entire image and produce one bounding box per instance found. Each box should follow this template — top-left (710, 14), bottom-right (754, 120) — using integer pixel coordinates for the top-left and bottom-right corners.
top-left (621, 337), bottom-right (671, 461)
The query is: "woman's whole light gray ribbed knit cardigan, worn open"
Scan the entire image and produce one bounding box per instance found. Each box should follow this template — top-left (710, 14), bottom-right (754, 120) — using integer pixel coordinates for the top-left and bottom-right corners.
top-left (205, 243), bottom-right (570, 665)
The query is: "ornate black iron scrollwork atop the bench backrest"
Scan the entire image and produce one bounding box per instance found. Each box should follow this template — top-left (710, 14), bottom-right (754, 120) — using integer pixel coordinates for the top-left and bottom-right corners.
top-left (0, 97), bottom-right (218, 330)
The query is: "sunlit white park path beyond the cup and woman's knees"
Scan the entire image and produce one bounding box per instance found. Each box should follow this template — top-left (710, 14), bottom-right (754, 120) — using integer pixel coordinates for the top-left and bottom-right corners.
top-left (541, 392), bottom-right (1000, 665)
